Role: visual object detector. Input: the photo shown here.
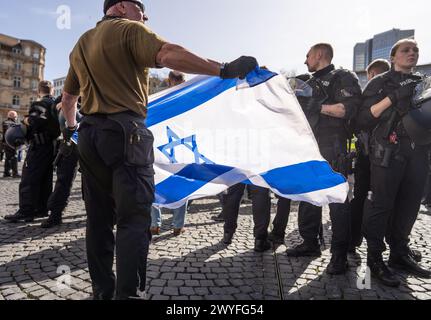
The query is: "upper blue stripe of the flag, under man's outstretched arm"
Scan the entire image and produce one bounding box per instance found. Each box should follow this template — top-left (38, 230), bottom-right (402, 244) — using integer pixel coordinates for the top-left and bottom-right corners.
top-left (146, 69), bottom-right (277, 127)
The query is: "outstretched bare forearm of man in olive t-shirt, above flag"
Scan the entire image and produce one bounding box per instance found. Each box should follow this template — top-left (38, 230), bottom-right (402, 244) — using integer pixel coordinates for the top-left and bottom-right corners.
top-left (157, 43), bottom-right (221, 76)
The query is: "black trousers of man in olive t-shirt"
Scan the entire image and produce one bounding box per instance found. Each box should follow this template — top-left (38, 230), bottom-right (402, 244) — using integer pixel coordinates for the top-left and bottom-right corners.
top-left (78, 116), bottom-right (154, 299)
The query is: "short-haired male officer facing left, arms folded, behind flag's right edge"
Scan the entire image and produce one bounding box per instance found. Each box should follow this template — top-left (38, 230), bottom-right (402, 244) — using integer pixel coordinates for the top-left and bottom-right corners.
top-left (286, 43), bottom-right (361, 274)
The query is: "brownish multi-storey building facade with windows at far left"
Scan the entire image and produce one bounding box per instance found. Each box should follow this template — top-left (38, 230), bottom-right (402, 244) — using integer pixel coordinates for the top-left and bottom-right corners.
top-left (0, 34), bottom-right (46, 121)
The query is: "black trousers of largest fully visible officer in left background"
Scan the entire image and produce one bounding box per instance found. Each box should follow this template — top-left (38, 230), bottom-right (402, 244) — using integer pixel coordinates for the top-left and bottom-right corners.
top-left (19, 142), bottom-right (54, 216)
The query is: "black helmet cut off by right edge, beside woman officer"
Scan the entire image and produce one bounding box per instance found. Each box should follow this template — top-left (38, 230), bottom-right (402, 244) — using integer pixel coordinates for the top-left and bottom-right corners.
top-left (403, 78), bottom-right (431, 146)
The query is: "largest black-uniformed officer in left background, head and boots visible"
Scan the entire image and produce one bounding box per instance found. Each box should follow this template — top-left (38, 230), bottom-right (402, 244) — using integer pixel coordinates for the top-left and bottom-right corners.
top-left (5, 81), bottom-right (60, 222)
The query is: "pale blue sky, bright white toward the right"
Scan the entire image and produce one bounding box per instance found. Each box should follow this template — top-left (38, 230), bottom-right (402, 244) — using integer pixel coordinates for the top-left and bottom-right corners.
top-left (0, 0), bottom-right (431, 80)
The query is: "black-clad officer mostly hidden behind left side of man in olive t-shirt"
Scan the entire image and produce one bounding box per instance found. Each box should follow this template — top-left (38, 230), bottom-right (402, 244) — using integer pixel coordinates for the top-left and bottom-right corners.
top-left (41, 96), bottom-right (80, 229)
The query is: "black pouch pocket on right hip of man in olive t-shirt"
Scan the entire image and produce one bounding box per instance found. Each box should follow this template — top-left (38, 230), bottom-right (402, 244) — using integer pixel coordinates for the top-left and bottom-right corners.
top-left (126, 121), bottom-right (154, 168)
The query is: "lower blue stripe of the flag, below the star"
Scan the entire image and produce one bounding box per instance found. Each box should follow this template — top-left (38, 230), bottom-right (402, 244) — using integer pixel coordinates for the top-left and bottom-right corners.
top-left (156, 161), bottom-right (346, 204)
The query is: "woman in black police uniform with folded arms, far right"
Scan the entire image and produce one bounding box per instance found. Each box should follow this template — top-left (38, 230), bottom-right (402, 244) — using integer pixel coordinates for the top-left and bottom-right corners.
top-left (358, 39), bottom-right (431, 287)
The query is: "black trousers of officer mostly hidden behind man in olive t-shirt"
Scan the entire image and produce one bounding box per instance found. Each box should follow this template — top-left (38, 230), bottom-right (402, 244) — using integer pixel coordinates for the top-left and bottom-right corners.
top-left (48, 146), bottom-right (79, 219)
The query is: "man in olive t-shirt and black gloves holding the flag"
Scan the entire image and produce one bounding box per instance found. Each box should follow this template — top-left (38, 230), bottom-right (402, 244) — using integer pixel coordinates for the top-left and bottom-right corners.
top-left (62, 0), bottom-right (257, 299)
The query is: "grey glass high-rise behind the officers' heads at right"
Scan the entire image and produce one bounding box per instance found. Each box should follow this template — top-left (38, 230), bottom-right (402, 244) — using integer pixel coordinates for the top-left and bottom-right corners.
top-left (353, 29), bottom-right (415, 71)
